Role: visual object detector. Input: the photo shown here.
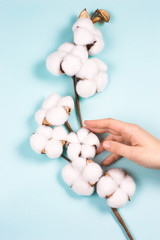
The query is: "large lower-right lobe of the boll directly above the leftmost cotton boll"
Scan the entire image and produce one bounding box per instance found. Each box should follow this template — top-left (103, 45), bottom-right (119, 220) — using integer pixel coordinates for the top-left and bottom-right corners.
top-left (46, 107), bottom-right (69, 126)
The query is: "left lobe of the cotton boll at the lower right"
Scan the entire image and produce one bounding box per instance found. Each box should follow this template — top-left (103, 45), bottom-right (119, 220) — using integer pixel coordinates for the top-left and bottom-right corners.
top-left (97, 176), bottom-right (117, 198)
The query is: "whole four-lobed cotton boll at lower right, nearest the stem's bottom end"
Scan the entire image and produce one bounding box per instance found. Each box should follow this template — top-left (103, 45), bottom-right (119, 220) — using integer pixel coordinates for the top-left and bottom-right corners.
top-left (97, 168), bottom-right (136, 208)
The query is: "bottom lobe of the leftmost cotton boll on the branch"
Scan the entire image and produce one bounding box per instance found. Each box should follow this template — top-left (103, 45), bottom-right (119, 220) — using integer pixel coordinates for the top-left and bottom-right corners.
top-left (45, 139), bottom-right (63, 158)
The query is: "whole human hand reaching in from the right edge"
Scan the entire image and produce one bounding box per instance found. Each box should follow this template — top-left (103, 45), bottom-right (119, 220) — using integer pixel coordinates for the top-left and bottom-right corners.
top-left (84, 118), bottom-right (160, 169)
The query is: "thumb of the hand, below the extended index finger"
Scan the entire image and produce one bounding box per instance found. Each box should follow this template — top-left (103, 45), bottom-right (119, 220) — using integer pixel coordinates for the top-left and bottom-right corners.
top-left (103, 141), bottom-right (134, 159)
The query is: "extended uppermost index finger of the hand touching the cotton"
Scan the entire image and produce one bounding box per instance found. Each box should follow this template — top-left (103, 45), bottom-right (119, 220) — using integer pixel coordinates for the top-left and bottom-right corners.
top-left (84, 118), bottom-right (129, 133)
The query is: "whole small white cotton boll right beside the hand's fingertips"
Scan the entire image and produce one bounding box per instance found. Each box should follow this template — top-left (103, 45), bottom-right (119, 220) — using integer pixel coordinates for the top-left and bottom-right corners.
top-left (67, 128), bottom-right (100, 161)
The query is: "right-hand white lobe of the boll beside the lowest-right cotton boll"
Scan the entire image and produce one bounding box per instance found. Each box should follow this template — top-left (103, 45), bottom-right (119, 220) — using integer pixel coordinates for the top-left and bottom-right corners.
top-left (82, 163), bottom-right (103, 184)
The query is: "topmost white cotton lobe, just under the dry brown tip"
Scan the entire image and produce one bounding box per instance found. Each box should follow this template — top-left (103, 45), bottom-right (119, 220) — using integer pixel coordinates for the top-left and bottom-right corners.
top-left (72, 18), bottom-right (95, 32)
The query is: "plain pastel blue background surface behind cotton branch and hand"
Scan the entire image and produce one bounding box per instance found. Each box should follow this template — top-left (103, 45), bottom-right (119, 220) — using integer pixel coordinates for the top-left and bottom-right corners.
top-left (0, 0), bottom-right (160, 240)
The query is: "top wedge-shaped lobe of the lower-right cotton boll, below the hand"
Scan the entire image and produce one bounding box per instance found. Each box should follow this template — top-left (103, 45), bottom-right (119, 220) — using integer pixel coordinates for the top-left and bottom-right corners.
top-left (107, 168), bottom-right (125, 185)
